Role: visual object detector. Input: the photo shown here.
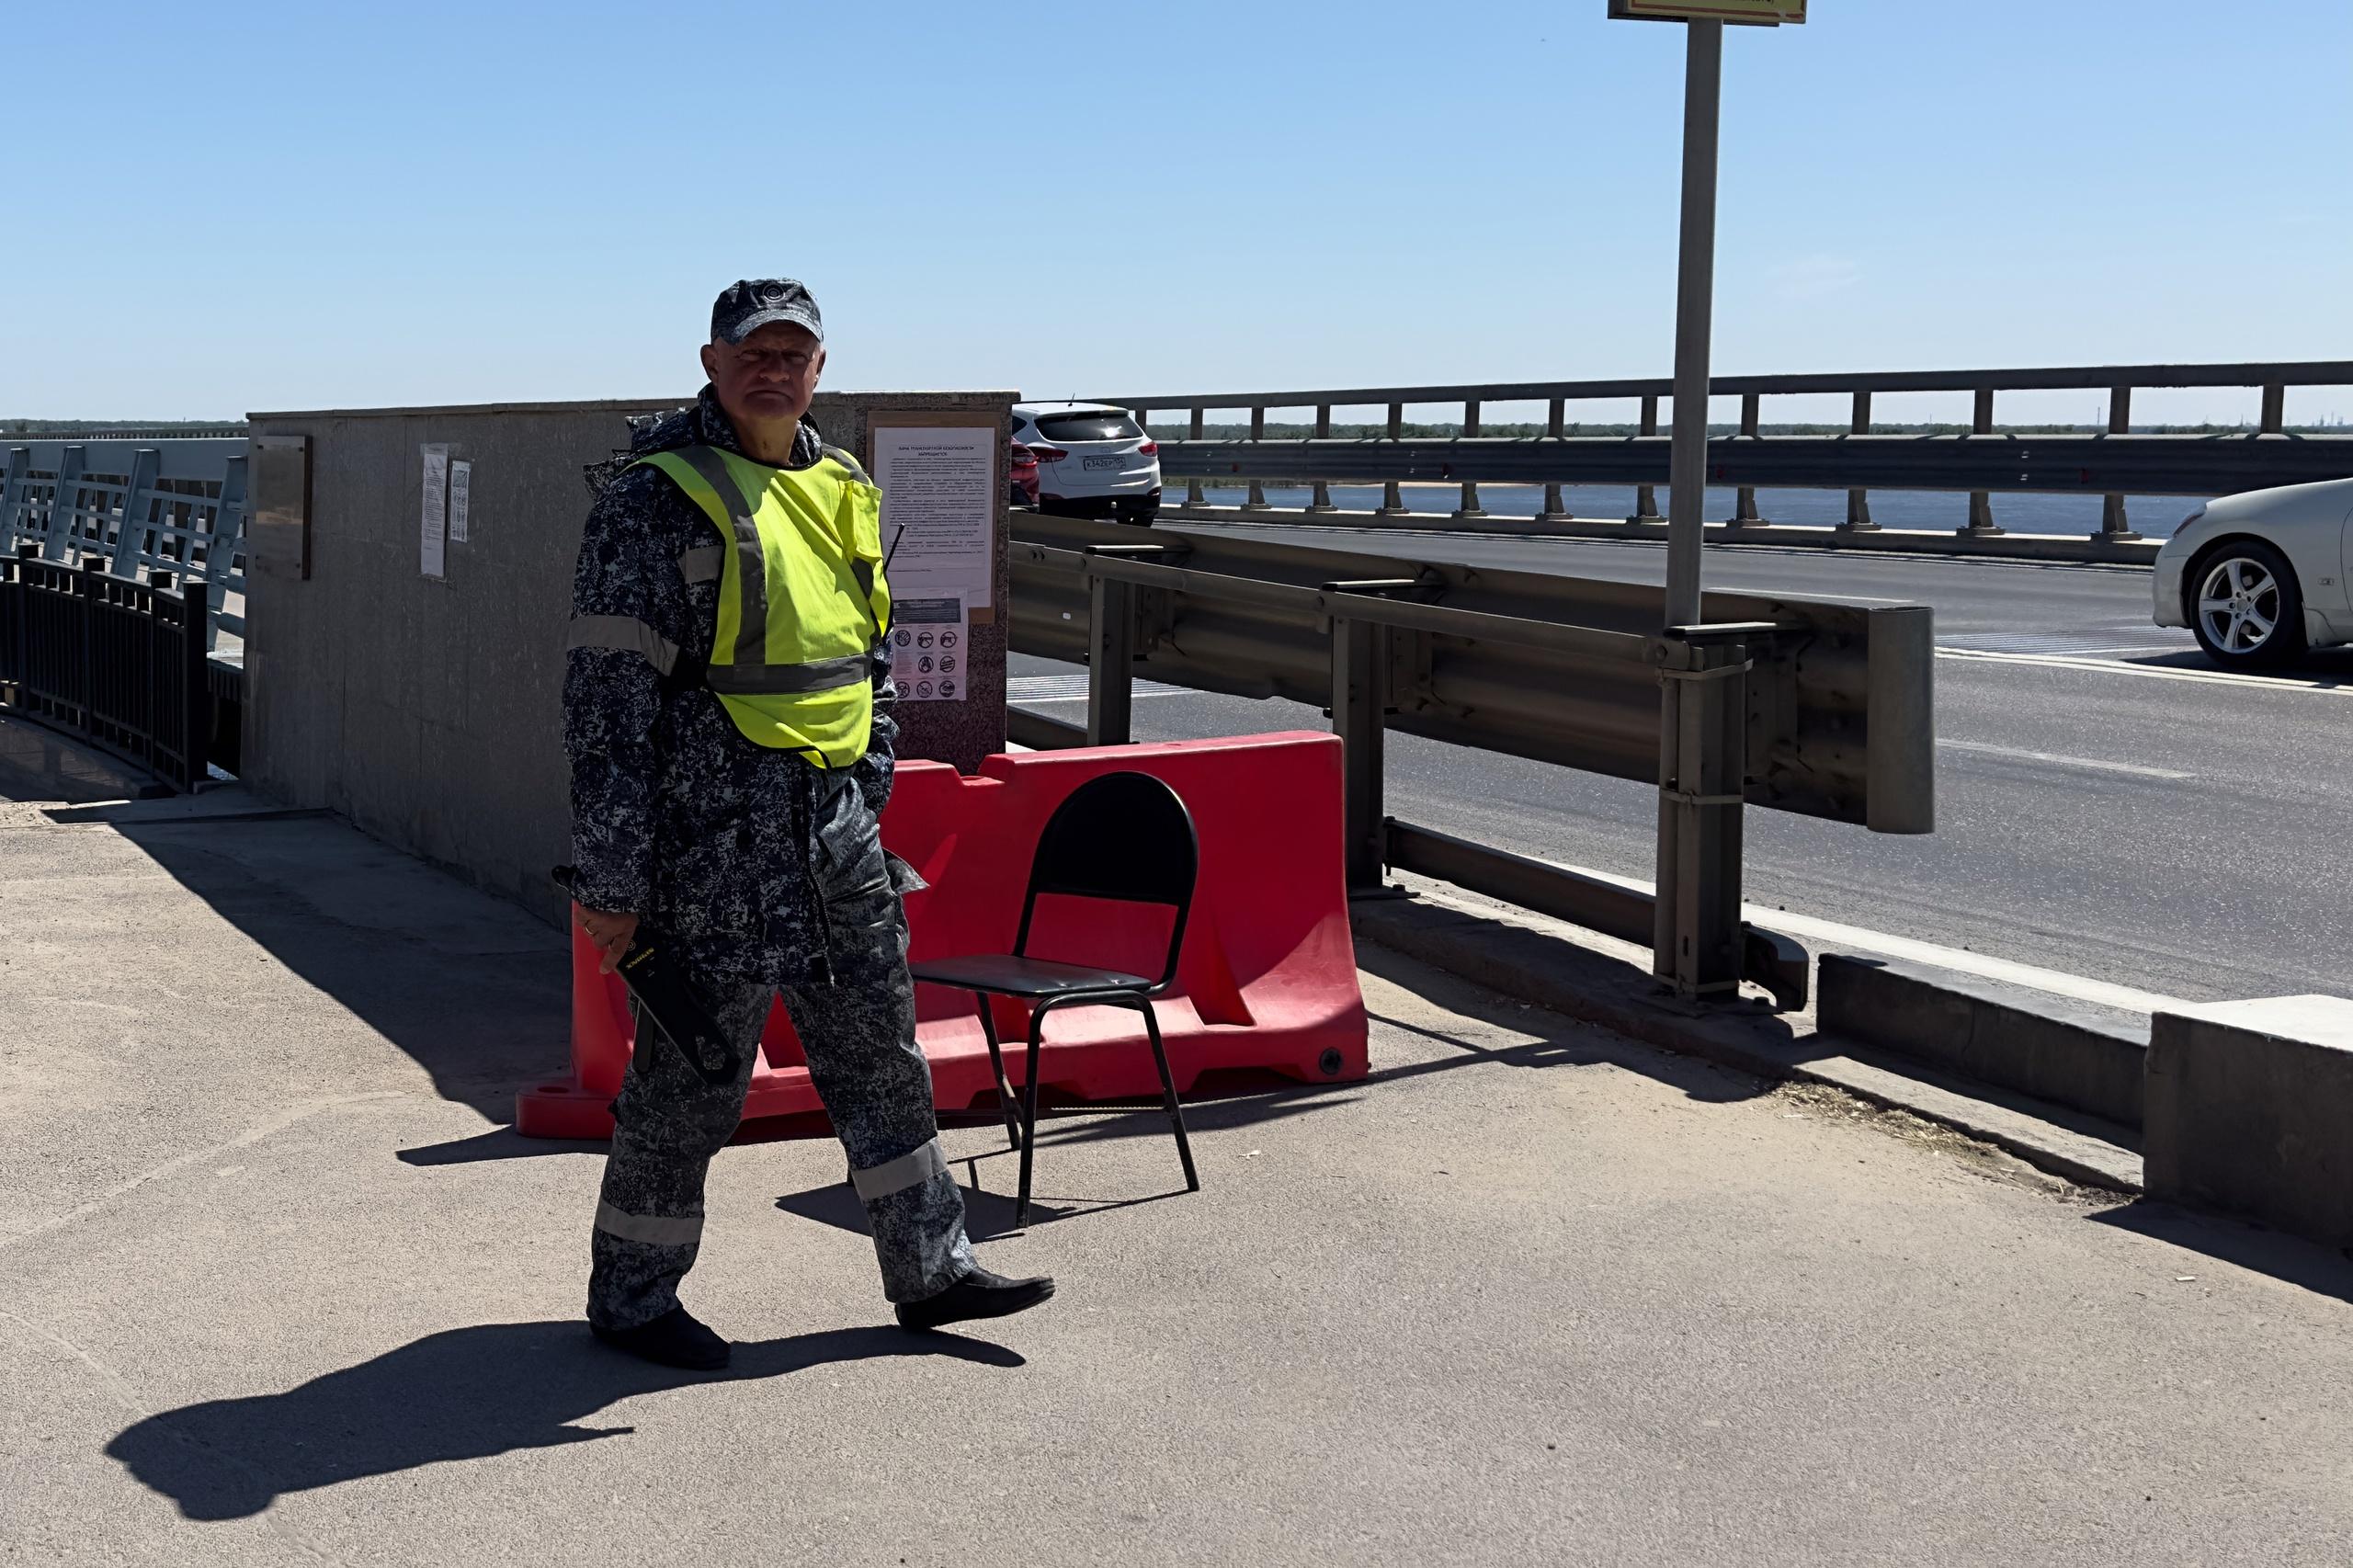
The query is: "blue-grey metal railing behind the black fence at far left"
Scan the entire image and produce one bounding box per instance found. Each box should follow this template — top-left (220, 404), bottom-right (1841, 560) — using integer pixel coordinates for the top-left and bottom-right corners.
top-left (0, 436), bottom-right (247, 647)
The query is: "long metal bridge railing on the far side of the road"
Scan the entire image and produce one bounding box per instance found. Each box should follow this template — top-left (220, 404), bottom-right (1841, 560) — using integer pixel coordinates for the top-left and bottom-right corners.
top-left (1106, 360), bottom-right (2353, 558)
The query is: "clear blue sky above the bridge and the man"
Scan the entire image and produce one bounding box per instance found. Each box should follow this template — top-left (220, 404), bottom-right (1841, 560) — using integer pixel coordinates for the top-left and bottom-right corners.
top-left (0, 0), bottom-right (2353, 419)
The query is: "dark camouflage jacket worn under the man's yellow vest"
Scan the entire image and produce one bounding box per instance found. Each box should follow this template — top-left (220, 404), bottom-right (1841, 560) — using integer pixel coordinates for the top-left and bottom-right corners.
top-left (564, 386), bottom-right (899, 984)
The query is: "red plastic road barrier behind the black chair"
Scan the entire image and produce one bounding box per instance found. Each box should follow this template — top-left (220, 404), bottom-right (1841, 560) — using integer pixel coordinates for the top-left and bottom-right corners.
top-left (516, 733), bottom-right (1365, 1137)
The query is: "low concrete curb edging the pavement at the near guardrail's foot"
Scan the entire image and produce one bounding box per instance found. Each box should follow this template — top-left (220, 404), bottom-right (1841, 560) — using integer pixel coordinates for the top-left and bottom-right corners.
top-left (1350, 890), bottom-right (2142, 1196)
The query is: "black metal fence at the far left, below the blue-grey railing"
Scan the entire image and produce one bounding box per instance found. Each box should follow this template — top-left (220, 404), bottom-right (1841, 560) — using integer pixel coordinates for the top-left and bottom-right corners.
top-left (0, 546), bottom-right (222, 789)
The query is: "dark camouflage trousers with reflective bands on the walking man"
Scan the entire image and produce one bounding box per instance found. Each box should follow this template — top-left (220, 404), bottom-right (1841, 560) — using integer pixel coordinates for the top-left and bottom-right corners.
top-left (588, 789), bottom-right (974, 1328)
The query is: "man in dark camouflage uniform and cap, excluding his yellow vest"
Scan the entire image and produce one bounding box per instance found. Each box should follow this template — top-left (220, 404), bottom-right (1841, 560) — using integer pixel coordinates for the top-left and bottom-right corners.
top-left (564, 278), bottom-right (1054, 1368)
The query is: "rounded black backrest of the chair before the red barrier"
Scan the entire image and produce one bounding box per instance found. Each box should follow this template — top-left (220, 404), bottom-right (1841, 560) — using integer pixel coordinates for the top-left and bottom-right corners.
top-left (1014, 772), bottom-right (1200, 991)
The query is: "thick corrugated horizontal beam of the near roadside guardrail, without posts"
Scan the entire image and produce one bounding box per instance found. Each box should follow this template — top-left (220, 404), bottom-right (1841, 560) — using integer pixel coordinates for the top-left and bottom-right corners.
top-left (1012, 513), bottom-right (1934, 834)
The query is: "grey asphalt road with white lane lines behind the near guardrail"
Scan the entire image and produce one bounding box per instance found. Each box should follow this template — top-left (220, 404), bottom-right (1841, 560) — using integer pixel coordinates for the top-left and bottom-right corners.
top-left (1014, 529), bottom-right (2353, 1001)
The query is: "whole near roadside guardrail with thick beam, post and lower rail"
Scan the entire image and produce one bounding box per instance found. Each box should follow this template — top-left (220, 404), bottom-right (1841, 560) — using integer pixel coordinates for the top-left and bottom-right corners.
top-left (1012, 516), bottom-right (1934, 1006)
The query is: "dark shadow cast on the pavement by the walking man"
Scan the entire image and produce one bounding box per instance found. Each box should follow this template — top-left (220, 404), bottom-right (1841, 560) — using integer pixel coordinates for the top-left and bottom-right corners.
top-left (106, 1318), bottom-right (1024, 1518)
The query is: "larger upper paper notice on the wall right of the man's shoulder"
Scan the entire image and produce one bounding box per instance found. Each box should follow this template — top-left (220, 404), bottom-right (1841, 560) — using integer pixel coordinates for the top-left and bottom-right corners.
top-left (873, 424), bottom-right (997, 612)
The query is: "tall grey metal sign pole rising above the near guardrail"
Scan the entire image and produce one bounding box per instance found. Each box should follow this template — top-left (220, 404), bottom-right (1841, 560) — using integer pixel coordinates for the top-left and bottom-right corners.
top-left (1665, 21), bottom-right (1724, 626)
